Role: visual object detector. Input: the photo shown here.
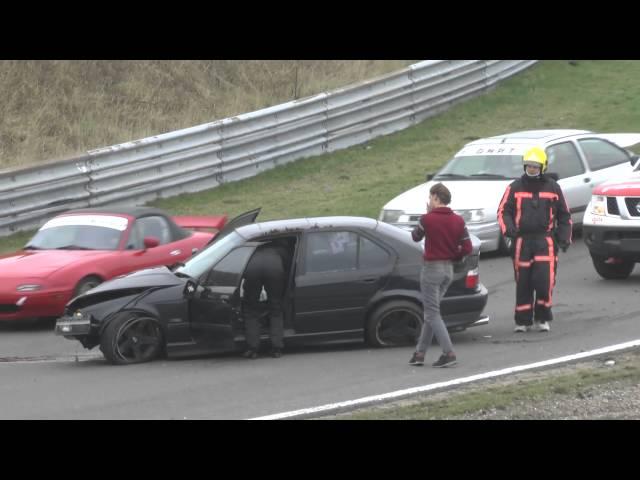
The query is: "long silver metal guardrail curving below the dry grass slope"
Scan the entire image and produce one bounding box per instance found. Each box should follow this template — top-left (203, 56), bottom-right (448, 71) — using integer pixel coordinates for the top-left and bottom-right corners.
top-left (0, 60), bottom-right (535, 235)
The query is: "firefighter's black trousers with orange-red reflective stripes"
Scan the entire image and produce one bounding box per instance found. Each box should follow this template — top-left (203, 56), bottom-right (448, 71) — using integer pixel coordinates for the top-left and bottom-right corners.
top-left (513, 236), bottom-right (558, 325)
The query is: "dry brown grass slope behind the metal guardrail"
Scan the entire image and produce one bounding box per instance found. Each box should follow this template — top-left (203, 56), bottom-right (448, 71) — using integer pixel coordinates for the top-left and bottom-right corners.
top-left (0, 60), bottom-right (414, 169)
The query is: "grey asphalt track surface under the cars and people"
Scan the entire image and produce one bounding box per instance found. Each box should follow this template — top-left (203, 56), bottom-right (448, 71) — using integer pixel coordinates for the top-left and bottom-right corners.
top-left (0, 238), bottom-right (640, 419)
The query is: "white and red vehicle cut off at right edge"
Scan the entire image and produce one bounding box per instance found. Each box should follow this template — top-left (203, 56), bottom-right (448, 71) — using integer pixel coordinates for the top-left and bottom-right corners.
top-left (583, 158), bottom-right (640, 279)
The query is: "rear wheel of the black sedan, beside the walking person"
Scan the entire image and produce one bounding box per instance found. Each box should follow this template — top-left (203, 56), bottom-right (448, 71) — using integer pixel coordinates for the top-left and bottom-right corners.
top-left (365, 300), bottom-right (423, 347)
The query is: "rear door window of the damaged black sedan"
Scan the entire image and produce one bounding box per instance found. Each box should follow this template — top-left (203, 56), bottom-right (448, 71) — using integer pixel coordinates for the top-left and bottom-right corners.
top-left (304, 232), bottom-right (358, 273)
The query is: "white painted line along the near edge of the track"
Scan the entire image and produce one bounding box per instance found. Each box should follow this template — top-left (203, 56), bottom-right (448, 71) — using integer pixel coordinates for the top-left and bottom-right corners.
top-left (249, 340), bottom-right (640, 420)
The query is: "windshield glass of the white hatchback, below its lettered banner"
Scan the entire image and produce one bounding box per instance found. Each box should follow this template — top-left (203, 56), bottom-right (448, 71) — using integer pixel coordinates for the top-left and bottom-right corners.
top-left (435, 155), bottom-right (523, 180)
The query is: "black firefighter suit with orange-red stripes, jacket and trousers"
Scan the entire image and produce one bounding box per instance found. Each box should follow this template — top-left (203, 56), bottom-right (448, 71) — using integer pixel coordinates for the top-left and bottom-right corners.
top-left (498, 173), bottom-right (571, 326)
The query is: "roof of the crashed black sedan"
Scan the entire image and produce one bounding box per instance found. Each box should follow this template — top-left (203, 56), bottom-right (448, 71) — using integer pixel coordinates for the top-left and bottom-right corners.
top-left (236, 216), bottom-right (378, 238)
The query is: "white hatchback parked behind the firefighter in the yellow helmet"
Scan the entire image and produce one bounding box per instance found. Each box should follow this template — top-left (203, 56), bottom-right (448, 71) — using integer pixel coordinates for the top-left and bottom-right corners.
top-left (379, 130), bottom-right (640, 253)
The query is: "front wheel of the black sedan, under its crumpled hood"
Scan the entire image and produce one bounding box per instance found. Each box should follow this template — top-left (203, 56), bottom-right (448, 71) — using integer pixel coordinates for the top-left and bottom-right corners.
top-left (100, 312), bottom-right (165, 365)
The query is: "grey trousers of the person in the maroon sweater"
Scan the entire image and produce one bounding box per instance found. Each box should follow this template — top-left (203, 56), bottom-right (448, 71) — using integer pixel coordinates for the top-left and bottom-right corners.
top-left (416, 260), bottom-right (453, 353)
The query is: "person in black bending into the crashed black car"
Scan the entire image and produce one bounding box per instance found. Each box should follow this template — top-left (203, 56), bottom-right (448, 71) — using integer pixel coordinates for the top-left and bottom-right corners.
top-left (242, 243), bottom-right (288, 359)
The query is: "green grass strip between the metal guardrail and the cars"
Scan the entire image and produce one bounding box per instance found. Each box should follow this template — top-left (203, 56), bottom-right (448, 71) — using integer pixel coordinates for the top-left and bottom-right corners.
top-left (0, 60), bottom-right (640, 255)
